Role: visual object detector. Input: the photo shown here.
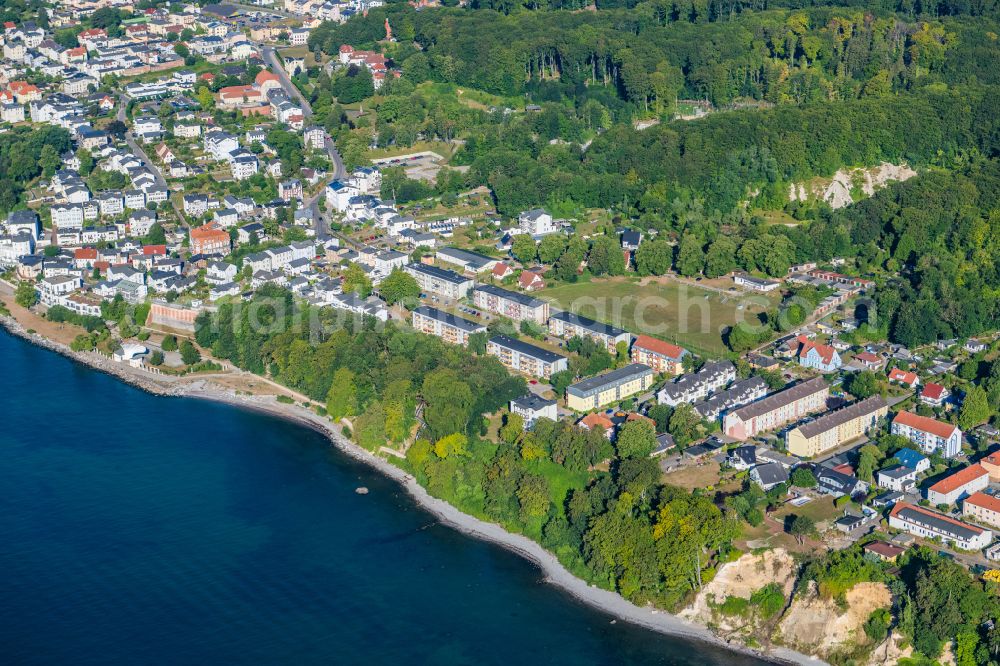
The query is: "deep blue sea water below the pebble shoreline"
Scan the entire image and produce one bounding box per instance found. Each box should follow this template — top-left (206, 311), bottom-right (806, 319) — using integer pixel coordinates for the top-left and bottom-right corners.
top-left (0, 333), bottom-right (760, 666)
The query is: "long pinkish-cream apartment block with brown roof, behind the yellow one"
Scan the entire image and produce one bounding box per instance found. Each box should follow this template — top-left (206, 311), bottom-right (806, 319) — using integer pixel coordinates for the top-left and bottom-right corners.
top-left (723, 377), bottom-right (830, 441)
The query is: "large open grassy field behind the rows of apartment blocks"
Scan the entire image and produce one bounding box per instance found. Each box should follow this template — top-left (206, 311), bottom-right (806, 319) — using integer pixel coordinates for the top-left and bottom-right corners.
top-left (537, 277), bottom-right (780, 357)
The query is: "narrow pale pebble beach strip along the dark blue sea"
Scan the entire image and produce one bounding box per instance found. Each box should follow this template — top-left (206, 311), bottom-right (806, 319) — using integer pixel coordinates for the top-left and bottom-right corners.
top-left (0, 316), bottom-right (825, 665)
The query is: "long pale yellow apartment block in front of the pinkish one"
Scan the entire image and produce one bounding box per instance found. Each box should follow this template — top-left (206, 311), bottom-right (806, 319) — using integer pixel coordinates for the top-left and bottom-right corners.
top-left (785, 395), bottom-right (889, 458)
